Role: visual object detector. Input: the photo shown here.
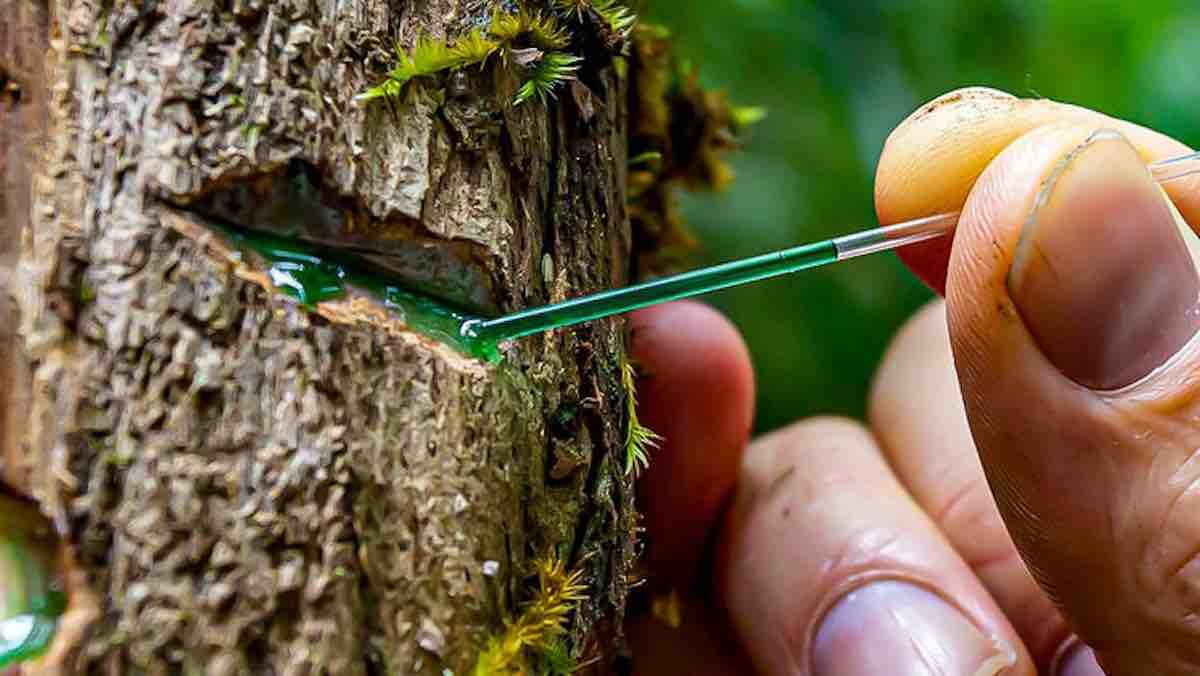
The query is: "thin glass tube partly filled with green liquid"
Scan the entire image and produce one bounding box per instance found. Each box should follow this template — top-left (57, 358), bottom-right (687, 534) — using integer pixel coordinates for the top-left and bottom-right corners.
top-left (461, 152), bottom-right (1200, 354)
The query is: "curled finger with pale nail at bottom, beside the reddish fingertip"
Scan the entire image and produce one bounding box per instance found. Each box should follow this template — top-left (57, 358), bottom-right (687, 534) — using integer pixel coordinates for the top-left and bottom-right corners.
top-left (714, 418), bottom-right (1032, 675)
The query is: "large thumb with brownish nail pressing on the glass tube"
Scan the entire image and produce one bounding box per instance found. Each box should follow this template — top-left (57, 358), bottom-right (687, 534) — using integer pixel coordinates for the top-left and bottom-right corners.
top-left (947, 122), bottom-right (1200, 675)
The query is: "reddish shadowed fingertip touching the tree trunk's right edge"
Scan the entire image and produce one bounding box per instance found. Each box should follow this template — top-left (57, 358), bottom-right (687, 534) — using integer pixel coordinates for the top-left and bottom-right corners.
top-left (631, 301), bottom-right (754, 586)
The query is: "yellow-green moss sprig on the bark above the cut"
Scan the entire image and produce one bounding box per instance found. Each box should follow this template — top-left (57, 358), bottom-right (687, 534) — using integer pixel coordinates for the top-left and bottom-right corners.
top-left (355, 10), bottom-right (582, 104)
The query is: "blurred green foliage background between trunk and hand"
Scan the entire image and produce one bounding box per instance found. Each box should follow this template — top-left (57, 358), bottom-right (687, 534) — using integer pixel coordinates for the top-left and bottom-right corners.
top-left (648, 0), bottom-right (1200, 431)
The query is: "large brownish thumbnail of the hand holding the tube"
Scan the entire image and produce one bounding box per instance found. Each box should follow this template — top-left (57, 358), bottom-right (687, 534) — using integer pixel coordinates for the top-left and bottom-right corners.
top-left (1008, 131), bottom-right (1200, 390)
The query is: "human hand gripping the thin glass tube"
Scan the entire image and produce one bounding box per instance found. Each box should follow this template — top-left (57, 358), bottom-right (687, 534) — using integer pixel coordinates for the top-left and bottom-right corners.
top-left (628, 90), bottom-right (1200, 676)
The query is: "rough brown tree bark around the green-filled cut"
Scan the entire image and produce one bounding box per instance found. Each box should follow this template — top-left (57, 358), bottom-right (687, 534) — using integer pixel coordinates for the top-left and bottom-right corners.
top-left (0, 0), bottom-right (635, 675)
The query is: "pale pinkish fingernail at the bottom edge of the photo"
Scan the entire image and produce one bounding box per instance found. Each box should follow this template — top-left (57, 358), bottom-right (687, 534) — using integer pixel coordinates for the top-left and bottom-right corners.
top-left (812, 581), bottom-right (1016, 676)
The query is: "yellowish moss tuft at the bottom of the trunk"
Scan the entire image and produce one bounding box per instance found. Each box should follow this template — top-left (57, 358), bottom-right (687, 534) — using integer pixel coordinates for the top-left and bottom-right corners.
top-left (472, 556), bottom-right (587, 676)
